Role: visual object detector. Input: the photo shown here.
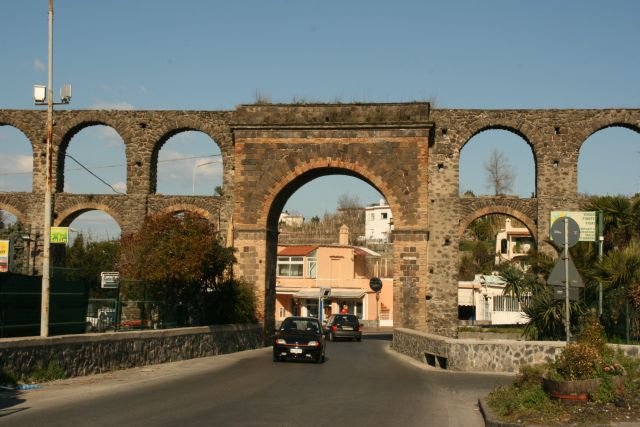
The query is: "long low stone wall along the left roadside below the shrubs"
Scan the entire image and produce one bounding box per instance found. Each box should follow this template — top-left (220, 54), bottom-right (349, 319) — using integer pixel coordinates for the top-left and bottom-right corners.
top-left (0, 324), bottom-right (264, 377)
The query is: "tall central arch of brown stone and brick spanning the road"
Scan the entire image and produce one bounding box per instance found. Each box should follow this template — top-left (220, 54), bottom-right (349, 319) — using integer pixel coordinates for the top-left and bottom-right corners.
top-left (228, 106), bottom-right (432, 331)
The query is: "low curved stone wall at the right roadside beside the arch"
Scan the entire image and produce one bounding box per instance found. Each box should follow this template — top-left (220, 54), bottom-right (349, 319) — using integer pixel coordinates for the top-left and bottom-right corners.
top-left (391, 328), bottom-right (640, 373)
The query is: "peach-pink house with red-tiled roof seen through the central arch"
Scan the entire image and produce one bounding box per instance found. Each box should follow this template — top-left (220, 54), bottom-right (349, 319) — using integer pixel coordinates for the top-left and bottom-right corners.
top-left (275, 229), bottom-right (393, 326)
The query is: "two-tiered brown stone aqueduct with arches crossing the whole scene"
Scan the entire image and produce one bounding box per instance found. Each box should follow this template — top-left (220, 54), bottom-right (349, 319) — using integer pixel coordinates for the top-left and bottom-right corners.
top-left (0, 103), bottom-right (640, 336)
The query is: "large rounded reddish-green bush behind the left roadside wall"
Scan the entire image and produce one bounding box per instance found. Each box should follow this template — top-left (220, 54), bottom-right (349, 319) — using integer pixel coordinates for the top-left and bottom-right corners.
top-left (117, 212), bottom-right (256, 326)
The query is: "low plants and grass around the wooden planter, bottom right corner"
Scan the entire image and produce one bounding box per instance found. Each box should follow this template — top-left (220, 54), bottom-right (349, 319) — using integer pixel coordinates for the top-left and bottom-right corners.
top-left (487, 315), bottom-right (640, 426)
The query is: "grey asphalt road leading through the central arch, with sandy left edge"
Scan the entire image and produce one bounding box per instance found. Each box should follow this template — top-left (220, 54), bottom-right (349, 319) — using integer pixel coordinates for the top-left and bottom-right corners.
top-left (0, 335), bottom-right (512, 427)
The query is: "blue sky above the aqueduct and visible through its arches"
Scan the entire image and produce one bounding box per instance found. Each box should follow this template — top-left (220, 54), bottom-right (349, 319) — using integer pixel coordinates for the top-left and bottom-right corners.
top-left (0, 0), bottom-right (640, 239)
